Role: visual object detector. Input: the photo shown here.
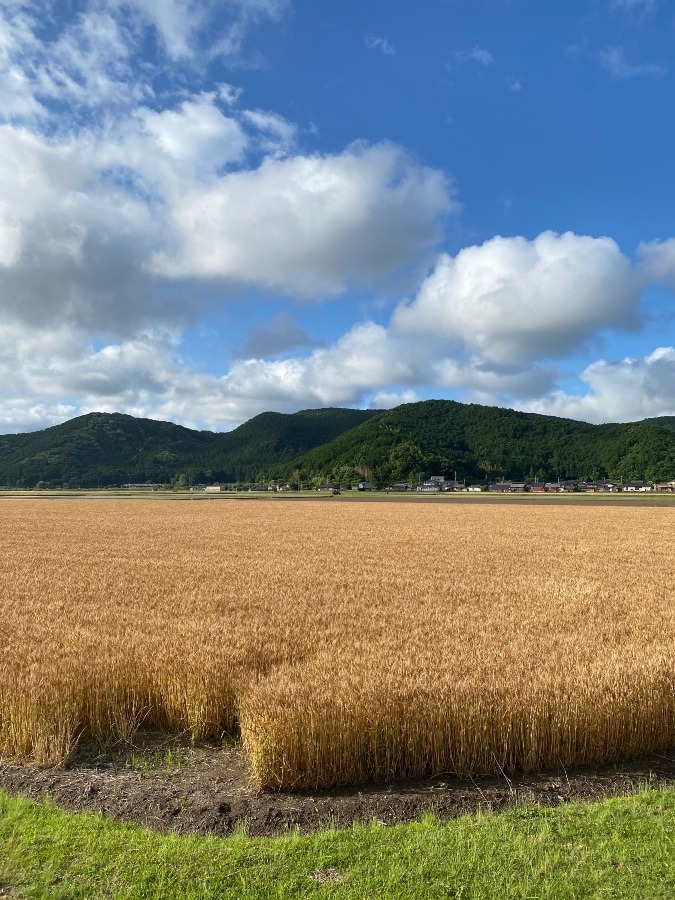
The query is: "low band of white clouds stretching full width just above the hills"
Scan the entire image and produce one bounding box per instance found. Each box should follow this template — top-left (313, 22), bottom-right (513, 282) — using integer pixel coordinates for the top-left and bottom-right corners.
top-left (0, 294), bottom-right (675, 431)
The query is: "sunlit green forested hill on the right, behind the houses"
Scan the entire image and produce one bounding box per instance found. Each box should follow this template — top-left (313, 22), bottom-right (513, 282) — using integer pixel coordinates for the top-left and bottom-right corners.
top-left (277, 400), bottom-right (675, 485)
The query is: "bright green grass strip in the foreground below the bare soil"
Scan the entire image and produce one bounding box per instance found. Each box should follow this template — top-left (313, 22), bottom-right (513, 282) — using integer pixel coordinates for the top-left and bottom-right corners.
top-left (0, 791), bottom-right (675, 900)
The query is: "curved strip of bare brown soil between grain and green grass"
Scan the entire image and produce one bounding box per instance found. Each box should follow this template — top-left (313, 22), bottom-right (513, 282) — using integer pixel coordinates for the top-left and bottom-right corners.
top-left (0, 734), bottom-right (675, 836)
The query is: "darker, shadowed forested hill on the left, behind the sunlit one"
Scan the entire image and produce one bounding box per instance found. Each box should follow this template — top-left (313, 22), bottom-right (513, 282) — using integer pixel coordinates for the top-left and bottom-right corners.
top-left (0, 409), bottom-right (375, 487)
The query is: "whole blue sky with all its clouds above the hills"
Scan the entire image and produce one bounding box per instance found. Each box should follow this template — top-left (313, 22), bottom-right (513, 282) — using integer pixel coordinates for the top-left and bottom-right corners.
top-left (0, 0), bottom-right (675, 432)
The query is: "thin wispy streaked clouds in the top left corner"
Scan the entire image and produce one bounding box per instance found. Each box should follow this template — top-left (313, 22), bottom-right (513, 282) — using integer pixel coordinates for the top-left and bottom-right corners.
top-left (0, 0), bottom-right (289, 130)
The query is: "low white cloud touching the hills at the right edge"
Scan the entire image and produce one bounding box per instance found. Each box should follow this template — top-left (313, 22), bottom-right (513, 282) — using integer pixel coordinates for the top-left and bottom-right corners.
top-left (519, 347), bottom-right (675, 423)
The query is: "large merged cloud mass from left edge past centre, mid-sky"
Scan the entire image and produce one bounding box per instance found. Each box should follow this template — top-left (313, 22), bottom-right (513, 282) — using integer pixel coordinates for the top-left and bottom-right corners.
top-left (0, 103), bottom-right (451, 335)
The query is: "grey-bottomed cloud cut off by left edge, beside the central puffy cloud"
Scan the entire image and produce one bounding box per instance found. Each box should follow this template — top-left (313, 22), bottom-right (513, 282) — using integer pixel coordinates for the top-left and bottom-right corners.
top-left (0, 125), bottom-right (169, 333)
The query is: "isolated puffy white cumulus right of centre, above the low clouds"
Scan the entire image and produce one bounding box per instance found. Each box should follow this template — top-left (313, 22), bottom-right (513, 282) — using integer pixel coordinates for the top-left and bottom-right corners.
top-left (392, 231), bottom-right (642, 365)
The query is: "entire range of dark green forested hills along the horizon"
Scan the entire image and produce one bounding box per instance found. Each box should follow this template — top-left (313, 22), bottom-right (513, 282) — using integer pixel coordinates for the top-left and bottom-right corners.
top-left (0, 400), bottom-right (675, 487)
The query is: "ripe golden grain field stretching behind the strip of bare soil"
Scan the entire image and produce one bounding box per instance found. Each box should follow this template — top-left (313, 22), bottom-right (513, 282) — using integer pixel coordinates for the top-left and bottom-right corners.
top-left (0, 499), bottom-right (675, 788)
